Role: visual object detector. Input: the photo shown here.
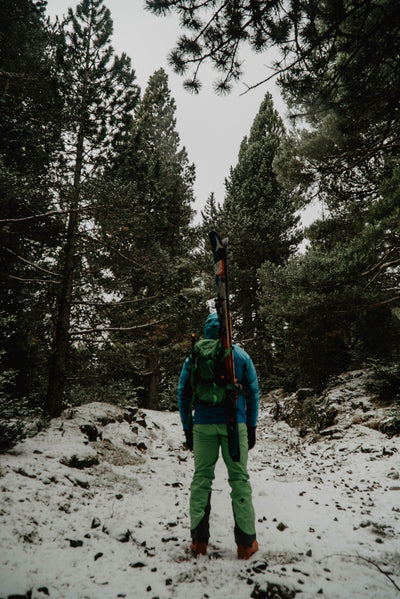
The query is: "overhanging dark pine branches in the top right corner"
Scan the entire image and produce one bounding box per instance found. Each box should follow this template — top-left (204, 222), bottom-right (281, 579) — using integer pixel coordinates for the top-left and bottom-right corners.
top-left (146, 0), bottom-right (400, 152)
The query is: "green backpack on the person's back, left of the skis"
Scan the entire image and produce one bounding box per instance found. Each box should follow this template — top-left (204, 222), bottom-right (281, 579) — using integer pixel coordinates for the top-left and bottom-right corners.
top-left (189, 339), bottom-right (232, 405)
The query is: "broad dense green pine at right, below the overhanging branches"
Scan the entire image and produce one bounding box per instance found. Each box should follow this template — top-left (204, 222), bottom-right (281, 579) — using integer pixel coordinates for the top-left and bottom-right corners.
top-left (260, 144), bottom-right (400, 391)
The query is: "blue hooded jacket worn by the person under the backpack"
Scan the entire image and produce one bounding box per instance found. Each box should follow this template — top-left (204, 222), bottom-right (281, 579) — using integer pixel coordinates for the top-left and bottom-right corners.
top-left (178, 312), bottom-right (260, 430)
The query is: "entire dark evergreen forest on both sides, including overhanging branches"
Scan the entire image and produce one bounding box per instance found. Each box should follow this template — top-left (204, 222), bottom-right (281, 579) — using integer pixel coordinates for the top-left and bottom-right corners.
top-left (0, 0), bottom-right (400, 426)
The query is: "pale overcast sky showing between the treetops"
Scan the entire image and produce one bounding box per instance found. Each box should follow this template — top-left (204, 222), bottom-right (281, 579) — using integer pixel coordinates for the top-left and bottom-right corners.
top-left (47, 0), bottom-right (285, 220)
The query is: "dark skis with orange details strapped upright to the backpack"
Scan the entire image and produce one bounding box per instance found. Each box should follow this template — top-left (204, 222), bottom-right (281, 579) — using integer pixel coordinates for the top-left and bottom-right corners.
top-left (209, 231), bottom-right (240, 462)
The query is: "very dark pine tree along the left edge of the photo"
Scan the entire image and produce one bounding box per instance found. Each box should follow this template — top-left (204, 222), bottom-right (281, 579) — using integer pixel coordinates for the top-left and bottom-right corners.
top-left (0, 0), bottom-right (60, 404)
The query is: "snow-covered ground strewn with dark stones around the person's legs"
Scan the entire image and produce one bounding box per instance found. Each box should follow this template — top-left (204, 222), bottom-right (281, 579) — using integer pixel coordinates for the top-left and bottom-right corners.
top-left (0, 386), bottom-right (400, 599)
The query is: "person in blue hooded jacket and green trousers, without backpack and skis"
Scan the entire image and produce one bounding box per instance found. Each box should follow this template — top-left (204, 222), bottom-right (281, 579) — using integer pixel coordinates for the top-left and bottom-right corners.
top-left (178, 313), bottom-right (259, 559)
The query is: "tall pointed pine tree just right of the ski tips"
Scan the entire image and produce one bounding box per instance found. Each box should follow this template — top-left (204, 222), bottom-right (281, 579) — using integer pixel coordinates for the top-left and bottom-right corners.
top-left (223, 94), bottom-right (299, 371)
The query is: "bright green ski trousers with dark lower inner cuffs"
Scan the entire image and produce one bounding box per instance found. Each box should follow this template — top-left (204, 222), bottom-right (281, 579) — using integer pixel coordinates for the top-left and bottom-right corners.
top-left (190, 423), bottom-right (256, 546)
